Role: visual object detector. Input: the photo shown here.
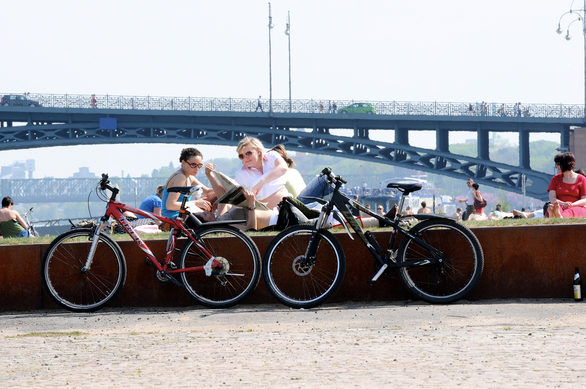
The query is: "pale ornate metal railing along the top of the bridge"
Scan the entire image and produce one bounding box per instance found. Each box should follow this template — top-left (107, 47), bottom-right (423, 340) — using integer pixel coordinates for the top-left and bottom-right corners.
top-left (0, 92), bottom-right (584, 119)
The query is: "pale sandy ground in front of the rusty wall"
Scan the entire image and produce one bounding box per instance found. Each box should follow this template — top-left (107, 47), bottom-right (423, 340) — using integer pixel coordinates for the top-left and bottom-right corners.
top-left (0, 300), bottom-right (586, 388)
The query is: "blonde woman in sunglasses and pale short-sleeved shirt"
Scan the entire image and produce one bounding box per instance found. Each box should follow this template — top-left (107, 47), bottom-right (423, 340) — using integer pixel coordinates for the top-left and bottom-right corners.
top-left (235, 137), bottom-right (290, 209)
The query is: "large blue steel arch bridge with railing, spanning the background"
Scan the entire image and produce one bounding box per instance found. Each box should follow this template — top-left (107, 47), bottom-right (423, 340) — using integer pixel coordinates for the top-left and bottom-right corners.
top-left (0, 94), bottom-right (584, 200)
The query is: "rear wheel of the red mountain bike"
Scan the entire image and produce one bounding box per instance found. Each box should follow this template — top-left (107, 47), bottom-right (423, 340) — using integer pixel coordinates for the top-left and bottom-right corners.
top-left (179, 226), bottom-right (261, 308)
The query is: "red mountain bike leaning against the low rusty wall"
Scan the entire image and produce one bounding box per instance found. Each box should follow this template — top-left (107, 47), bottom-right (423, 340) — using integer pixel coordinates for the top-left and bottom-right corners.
top-left (42, 174), bottom-right (260, 312)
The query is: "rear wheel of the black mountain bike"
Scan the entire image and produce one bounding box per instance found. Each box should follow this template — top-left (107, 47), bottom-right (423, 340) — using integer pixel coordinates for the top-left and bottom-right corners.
top-left (398, 219), bottom-right (484, 304)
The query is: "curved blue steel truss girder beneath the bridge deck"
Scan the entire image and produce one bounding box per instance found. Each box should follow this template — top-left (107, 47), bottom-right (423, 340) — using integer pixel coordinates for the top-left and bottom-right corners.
top-left (0, 120), bottom-right (550, 200)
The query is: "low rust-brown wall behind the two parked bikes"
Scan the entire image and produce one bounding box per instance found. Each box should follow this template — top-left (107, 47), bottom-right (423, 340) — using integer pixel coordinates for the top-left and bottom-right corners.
top-left (0, 224), bottom-right (586, 311)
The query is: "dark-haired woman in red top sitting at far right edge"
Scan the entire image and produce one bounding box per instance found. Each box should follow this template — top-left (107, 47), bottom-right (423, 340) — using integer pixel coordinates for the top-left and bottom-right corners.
top-left (547, 153), bottom-right (586, 218)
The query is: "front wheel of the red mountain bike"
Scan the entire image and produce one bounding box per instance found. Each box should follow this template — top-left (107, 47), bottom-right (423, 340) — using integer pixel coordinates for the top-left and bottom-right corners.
top-left (41, 228), bottom-right (126, 312)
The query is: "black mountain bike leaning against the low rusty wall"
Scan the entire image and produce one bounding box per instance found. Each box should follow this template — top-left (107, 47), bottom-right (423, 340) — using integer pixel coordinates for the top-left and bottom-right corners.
top-left (262, 168), bottom-right (484, 308)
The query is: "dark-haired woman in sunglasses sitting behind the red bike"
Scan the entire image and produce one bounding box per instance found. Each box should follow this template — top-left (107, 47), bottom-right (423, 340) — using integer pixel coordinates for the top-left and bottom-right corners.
top-left (161, 147), bottom-right (215, 218)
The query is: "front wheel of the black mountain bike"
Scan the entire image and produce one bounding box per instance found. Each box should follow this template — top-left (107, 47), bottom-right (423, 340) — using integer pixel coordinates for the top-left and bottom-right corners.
top-left (262, 225), bottom-right (346, 308)
